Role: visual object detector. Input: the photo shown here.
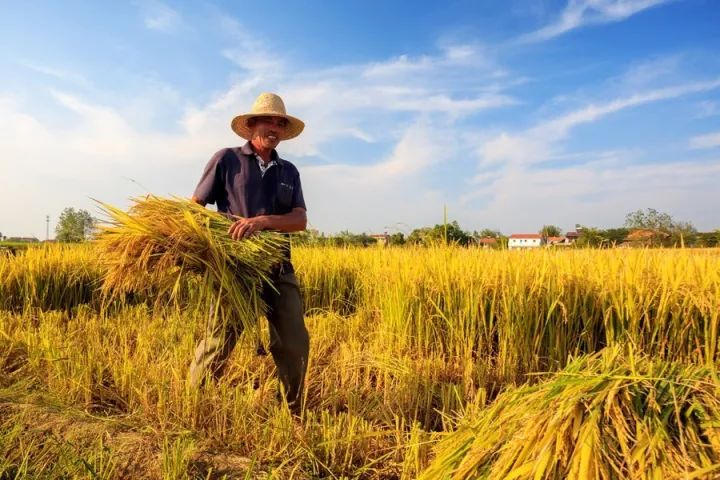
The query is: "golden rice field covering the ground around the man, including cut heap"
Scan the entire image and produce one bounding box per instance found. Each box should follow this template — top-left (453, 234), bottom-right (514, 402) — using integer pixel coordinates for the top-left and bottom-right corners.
top-left (0, 245), bottom-right (720, 480)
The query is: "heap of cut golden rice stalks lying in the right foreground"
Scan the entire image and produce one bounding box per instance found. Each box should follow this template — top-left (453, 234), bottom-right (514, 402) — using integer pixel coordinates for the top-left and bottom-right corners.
top-left (421, 348), bottom-right (720, 480)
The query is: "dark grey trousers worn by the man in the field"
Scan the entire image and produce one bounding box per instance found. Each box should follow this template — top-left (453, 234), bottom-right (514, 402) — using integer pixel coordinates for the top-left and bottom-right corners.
top-left (190, 272), bottom-right (310, 407)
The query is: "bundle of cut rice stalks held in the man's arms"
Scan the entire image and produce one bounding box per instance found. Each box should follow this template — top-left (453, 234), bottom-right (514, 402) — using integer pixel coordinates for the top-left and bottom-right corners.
top-left (97, 196), bottom-right (286, 328)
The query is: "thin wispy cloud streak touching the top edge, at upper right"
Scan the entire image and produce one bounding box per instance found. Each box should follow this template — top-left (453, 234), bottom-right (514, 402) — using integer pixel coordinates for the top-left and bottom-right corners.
top-left (520, 0), bottom-right (670, 42)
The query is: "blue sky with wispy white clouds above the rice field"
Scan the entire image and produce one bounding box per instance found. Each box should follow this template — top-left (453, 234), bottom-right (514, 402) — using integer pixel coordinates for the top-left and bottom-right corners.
top-left (0, 0), bottom-right (720, 239)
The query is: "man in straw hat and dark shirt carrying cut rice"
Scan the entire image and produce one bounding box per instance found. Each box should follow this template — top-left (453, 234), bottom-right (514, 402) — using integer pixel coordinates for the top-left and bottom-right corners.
top-left (190, 93), bottom-right (310, 410)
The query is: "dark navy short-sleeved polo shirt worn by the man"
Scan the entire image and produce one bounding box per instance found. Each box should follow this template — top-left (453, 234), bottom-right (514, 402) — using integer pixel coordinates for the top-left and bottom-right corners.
top-left (193, 142), bottom-right (307, 268)
